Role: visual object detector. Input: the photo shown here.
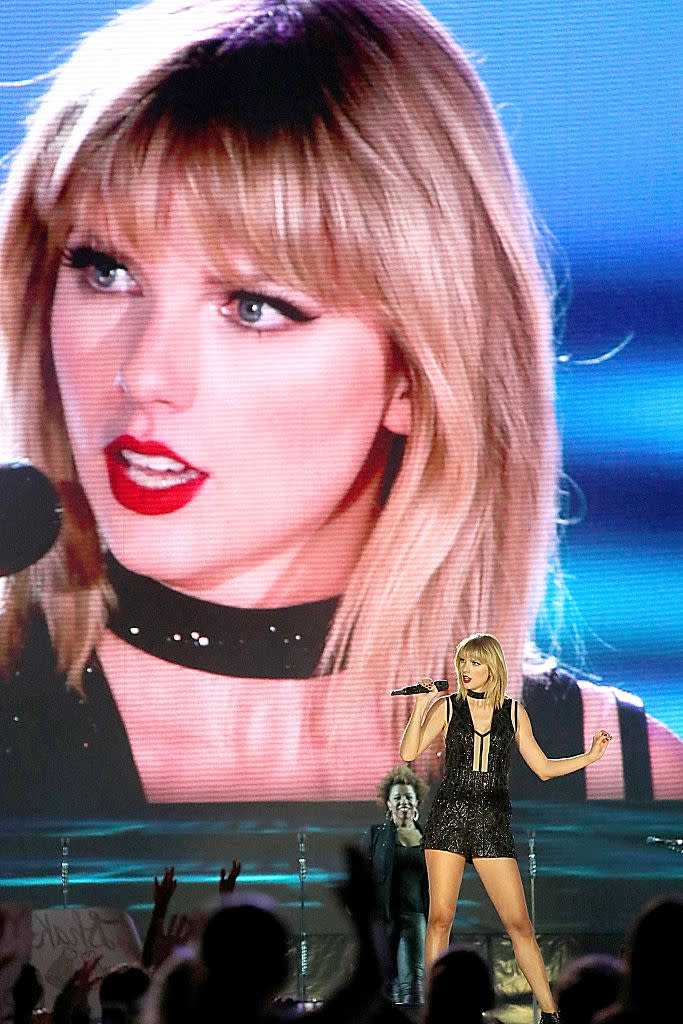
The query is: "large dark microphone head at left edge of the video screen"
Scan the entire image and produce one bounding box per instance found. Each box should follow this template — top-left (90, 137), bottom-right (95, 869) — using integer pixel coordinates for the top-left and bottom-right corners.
top-left (0, 462), bottom-right (62, 577)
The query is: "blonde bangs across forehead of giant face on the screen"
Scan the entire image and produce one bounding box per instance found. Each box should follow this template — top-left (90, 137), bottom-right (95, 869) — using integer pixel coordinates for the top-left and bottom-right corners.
top-left (49, 104), bottom-right (395, 318)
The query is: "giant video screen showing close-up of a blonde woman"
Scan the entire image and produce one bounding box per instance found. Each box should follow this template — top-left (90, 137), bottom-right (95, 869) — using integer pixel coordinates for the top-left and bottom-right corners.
top-left (0, 0), bottom-right (683, 999)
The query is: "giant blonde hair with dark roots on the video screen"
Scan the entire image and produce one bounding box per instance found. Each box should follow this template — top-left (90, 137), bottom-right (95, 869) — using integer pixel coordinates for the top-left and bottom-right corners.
top-left (0, 0), bottom-right (557, 696)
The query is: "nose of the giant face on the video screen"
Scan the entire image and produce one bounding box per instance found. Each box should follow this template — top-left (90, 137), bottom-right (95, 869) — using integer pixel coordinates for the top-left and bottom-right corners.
top-left (117, 297), bottom-right (201, 411)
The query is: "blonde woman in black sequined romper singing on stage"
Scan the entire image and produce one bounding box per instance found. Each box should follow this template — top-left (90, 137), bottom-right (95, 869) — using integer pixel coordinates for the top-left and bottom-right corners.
top-left (400, 633), bottom-right (611, 1024)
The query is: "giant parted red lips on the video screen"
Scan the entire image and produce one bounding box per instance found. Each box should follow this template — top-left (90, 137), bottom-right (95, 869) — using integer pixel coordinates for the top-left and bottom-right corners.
top-left (104, 434), bottom-right (208, 515)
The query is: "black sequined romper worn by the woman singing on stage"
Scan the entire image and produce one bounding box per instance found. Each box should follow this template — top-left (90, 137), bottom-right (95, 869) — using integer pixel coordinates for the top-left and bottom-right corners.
top-left (423, 696), bottom-right (519, 862)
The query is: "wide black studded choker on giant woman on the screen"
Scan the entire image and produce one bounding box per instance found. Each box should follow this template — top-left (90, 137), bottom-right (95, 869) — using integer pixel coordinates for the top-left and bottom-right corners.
top-left (106, 554), bottom-right (339, 679)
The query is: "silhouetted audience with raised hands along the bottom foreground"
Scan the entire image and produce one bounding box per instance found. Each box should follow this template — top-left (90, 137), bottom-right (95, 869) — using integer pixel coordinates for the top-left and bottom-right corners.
top-left (0, 849), bottom-right (683, 1024)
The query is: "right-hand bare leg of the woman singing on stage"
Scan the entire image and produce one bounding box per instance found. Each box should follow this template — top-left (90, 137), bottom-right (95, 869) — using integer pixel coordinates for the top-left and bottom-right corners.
top-left (472, 857), bottom-right (556, 1013)
